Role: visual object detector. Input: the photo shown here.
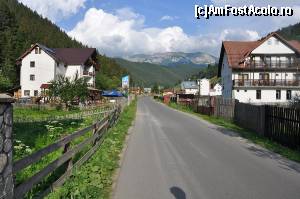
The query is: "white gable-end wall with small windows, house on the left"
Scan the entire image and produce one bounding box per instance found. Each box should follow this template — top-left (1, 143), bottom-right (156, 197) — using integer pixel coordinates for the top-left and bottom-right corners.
top-left (20, 46), bottom-right (55, 97)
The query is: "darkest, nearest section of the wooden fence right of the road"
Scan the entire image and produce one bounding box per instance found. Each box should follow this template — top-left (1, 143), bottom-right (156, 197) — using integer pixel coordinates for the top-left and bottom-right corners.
top-left (234, 103), bottom-right (300, 149)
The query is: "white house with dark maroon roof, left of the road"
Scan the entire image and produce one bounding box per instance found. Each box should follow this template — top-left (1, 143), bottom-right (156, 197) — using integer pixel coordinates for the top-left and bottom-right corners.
top-left (17, 43), bottom-right (98, 97)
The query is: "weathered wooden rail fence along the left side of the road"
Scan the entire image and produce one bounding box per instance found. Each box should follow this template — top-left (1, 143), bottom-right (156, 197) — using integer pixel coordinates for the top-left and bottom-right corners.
top-left (13, 106), bottom-right (121, 198)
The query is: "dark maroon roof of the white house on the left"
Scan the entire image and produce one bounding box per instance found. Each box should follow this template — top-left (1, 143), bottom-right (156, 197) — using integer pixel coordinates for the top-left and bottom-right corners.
top-left (17, 43), bottom-right (96, 65)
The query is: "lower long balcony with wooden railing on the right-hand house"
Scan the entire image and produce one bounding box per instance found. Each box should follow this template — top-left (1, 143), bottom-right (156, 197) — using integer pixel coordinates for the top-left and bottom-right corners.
top-left (233, 79), bottom-right (300, 87)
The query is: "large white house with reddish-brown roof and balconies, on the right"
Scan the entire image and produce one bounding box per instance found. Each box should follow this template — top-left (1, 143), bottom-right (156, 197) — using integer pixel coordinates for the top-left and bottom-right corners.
top-left (218, 33), bottom-right (300, 103)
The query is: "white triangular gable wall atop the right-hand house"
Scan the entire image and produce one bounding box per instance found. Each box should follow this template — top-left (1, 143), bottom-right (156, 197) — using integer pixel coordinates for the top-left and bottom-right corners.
top-left (252, 37), bottom-right (295, 54)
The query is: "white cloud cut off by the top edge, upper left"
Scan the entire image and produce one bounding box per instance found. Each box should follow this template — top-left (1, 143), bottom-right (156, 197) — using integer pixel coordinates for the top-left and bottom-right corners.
top-left (18, 0), bottom-right (86, 22)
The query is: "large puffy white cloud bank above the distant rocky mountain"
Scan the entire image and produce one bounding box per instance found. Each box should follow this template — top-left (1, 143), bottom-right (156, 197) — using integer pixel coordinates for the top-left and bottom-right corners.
top-left (68, 8), bottom-right (258, 56)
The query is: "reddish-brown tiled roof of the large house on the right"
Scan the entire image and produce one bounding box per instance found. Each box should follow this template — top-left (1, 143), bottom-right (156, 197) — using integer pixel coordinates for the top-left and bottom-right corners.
top-left (218, 32), bottom-right (300, 76)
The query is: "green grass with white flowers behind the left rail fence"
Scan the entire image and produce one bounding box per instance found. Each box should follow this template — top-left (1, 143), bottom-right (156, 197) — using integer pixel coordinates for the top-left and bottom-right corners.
top-left (13, 108), bottom-right (109, 198)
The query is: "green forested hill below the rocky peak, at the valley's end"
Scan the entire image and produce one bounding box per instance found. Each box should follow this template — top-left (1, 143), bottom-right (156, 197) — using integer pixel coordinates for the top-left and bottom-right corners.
top-left (115, 58), bottom-right (206, 87)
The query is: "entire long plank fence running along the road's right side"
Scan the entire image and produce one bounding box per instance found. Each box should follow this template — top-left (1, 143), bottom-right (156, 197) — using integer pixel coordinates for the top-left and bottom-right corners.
top-left (166, 96), bottom-right (300, 149)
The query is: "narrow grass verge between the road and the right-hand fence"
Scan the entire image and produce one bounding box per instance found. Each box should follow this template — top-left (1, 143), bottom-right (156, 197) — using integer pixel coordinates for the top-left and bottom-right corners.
top-left (165, 103), bottom-right (300, 162)
